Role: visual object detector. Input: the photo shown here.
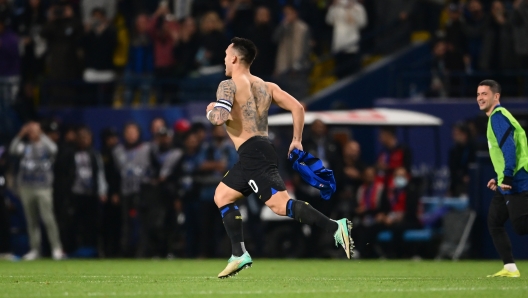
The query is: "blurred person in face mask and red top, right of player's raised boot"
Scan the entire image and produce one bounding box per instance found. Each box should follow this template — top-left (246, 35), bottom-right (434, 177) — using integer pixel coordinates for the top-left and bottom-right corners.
top-left (383, 167), bottom-right (421, 258)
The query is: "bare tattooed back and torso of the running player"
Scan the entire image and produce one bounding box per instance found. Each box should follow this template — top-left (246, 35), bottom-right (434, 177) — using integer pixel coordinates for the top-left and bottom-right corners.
top-left (222, 75), bottom-right (273, 150)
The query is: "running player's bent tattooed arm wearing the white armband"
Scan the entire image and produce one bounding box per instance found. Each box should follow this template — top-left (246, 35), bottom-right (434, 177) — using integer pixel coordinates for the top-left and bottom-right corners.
top-left (207, 80), bottom-right (236, 125)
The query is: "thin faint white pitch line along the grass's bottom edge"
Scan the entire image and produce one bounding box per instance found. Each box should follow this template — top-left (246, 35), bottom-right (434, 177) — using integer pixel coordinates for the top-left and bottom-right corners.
top-left (0, 286), bottom-right (528, 297)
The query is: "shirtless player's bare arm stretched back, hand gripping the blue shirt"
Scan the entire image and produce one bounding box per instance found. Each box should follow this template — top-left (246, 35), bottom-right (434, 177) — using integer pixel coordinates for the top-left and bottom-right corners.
top-left (267, 83), bottom-right (304, 156)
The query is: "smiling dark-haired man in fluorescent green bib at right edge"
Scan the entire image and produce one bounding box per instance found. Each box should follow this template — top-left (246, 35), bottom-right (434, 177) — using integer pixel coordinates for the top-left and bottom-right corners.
top-left (477, 80), bottom-right (528, 277)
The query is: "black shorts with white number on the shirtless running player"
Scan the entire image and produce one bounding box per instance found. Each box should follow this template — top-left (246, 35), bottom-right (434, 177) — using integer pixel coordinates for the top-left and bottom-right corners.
top-left (222, 136), bottom-right (286, 202)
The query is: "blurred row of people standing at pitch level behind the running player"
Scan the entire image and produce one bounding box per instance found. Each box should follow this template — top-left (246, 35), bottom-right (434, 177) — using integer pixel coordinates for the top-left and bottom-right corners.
top-left (0, 114), bottom-right (477, 260)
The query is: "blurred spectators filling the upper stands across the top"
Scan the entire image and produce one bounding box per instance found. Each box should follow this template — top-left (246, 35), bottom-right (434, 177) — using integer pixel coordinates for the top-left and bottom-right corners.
top-left (4, 0), bottom-right (528, 105)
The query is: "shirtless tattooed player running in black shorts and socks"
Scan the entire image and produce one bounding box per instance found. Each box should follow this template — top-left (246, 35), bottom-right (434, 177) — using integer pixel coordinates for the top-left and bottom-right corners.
top-left (207, 38), bottom-right (353, 278)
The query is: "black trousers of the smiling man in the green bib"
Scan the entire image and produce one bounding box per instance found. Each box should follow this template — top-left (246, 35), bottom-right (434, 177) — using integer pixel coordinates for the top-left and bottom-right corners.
top-left (488, 191), bottom-right (528, 264)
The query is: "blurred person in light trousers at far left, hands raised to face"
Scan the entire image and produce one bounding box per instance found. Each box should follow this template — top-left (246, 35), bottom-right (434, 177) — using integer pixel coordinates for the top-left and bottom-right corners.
top-left (9, 122), bottom-right (64, 261)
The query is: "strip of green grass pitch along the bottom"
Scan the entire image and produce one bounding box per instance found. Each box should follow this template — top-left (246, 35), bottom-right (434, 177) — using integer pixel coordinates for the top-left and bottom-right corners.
top-left (0, 259), bottom-right (528, 298)
